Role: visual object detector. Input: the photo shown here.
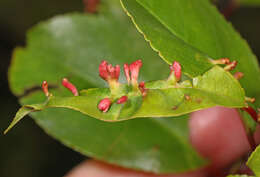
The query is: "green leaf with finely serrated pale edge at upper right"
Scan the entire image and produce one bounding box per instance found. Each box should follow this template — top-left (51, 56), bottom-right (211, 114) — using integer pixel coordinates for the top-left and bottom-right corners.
top-left (121, 0), bottom-right (260, 105)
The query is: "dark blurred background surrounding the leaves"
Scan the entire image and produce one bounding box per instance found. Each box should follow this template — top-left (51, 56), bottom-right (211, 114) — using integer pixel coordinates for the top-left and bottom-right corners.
top-left (0, 0), bottom-right (260, 177)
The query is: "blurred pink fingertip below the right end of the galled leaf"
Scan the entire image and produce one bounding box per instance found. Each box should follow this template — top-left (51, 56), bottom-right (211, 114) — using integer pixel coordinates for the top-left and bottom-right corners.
top-left (190, 107), bottom-right (254, 169)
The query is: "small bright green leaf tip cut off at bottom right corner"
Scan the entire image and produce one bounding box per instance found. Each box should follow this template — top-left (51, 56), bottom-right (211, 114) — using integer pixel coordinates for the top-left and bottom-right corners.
top-left (247, 146), bottom-right (260, 177)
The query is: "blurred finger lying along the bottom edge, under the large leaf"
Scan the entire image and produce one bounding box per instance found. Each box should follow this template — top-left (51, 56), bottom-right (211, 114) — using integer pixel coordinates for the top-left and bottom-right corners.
top-left (66, 160), bottom-right (204, 177)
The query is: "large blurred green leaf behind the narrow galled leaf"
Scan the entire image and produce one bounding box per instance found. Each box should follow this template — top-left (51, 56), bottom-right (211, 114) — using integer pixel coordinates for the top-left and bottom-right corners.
top-left (9, 1), bottom-right (206, 173)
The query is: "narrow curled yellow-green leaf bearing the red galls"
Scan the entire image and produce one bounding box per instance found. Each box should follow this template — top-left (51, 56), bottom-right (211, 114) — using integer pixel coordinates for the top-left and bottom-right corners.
top-left (8, 66), bottom-right (246, 129)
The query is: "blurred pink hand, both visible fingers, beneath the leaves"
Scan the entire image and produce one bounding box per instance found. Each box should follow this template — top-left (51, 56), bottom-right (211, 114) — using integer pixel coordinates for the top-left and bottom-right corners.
top-left (65, 107), bottom-right (260, 177)
